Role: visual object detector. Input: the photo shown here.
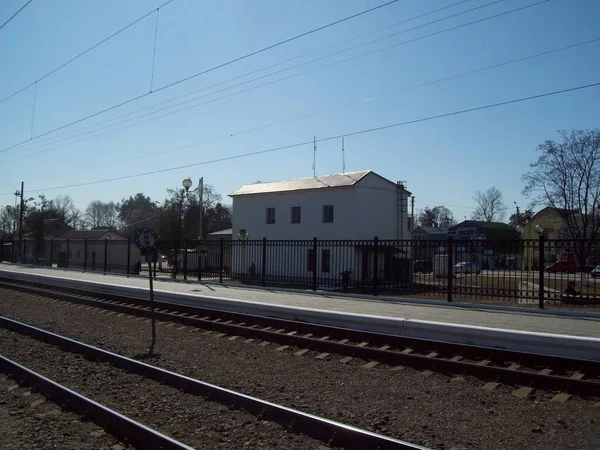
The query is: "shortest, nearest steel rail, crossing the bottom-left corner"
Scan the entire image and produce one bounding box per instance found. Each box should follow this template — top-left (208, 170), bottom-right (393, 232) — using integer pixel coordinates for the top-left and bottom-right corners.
top-left (0, 355), bottom-right (193, 450)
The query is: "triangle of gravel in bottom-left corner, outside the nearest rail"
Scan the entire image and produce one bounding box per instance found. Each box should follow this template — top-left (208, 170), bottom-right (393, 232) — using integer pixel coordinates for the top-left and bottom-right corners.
top-left (0, 372), bottom-right (126, 450)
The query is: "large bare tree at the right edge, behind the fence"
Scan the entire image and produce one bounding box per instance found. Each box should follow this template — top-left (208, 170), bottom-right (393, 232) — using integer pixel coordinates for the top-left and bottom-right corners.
top-left (523, 128), bottom-right (600, 274)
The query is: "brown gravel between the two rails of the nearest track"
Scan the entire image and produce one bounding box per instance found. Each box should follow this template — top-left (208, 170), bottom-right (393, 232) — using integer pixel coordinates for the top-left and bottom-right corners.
top-left (0, 329), bottom-right (332, 450)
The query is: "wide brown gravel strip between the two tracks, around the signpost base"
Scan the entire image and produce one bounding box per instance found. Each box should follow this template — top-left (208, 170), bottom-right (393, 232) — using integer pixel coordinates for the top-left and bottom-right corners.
top-left (0, 290), bottom-right (600, 450)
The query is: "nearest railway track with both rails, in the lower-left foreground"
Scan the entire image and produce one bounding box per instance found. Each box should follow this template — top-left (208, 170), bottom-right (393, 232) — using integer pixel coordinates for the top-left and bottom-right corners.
top-left (0, 316), bottom-right (424, 450)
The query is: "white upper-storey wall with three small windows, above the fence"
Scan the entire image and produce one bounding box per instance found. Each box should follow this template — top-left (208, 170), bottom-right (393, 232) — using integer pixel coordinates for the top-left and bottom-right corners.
top-left (233, 174), bottom-right (411, 240)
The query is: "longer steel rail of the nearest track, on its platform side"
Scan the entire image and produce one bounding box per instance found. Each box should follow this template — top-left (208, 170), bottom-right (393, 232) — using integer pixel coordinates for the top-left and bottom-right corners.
top-left (0, 316), bottom-right (426, 450)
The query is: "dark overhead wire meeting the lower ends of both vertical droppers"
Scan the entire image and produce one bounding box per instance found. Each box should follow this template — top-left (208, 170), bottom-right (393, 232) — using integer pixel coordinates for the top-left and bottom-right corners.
top-left (0, 0), bottom-right (404, 153)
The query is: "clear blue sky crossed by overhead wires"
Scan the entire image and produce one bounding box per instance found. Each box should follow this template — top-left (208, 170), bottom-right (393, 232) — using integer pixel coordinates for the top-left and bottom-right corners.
top-left (0, 0), bottom-right (600, 219)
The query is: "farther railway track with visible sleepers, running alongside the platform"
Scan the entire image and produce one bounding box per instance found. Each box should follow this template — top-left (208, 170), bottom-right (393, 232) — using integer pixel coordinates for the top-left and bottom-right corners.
top-left (0, 280), bottom-right (600, 401)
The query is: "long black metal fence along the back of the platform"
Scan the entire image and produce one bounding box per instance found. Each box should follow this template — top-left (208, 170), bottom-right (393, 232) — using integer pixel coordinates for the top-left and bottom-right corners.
top-left (1, 236), bottom-right (600, 308)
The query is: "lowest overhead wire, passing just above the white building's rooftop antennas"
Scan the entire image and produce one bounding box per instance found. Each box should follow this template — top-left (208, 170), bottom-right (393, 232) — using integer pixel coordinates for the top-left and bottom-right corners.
top-left (1, 81), bottom-right (600, 195)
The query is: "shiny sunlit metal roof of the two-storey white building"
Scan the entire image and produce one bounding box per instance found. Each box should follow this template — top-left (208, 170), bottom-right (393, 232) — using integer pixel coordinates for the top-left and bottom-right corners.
top-left (229, 170), bottom-right (371, 197)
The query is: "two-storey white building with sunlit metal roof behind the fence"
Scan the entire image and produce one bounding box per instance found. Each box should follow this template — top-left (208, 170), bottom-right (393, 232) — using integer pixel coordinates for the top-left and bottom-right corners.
top-left (230, 170), bottom-right (412, 283)
